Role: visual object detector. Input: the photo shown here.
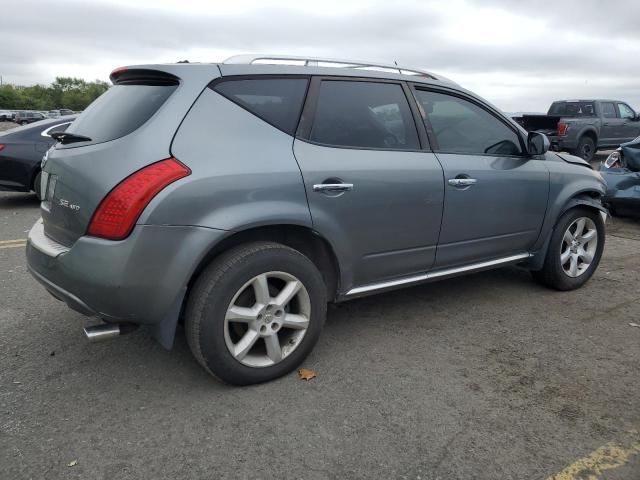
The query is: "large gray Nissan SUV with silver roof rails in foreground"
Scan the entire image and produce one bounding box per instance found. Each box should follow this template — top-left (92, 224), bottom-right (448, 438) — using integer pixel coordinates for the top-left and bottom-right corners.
top-left (27, 56), bottom-right (606, 384)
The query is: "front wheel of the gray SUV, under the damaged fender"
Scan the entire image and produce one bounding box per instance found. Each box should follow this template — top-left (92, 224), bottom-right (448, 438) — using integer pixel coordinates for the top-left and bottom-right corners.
top-left (531, 208), bottom-right (605, 290)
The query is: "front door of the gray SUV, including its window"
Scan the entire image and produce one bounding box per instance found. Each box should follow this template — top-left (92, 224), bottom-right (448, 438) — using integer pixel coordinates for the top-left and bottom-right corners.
top-left (415, 87), bottom-right (549, 269)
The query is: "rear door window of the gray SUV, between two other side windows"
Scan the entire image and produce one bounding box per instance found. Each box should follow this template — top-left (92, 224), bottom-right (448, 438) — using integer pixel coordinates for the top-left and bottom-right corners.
top-left (310, 80), bottom-right (420, 150)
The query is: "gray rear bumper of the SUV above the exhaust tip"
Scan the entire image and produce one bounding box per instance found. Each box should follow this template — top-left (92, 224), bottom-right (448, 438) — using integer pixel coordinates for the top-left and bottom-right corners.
top-left (27, 219), bottom-right (226, 325)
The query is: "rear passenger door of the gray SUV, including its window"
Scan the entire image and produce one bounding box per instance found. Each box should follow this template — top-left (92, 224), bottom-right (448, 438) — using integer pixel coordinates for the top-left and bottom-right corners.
top-left (294, 77), bottom-right (444, 290)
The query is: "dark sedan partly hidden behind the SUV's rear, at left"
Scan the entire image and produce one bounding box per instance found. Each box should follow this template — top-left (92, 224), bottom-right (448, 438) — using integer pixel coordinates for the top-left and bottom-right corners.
top-left (0, 116), bottom-right (76, 198)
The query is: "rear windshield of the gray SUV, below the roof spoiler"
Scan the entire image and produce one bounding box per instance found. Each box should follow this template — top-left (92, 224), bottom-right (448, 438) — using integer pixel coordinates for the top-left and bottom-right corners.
top-left (68, 84), bottom-right (177, 143)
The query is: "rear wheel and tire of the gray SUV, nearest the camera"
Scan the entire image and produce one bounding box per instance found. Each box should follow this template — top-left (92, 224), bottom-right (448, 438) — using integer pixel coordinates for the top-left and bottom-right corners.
top-left (185, 242), bottom-right (327, 385)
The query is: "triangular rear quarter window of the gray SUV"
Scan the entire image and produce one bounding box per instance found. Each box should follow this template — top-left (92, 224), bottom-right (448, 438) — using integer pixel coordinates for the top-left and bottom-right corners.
top-left (214, 78), bottom-right (309, 135)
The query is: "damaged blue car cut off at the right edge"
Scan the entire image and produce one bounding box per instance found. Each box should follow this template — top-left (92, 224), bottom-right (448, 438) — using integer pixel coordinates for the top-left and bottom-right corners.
top-left (600, 137), bottom-right (640, 216)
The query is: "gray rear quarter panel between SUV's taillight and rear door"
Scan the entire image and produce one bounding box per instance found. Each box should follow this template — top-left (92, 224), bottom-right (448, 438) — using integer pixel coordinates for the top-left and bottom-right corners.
top-left (146, 89), bottom-right (311, 230)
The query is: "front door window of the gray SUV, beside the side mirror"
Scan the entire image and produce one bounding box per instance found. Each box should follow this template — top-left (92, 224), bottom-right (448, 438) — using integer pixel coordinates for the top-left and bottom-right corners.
top-left (416, 90), bottom-right (522, 155)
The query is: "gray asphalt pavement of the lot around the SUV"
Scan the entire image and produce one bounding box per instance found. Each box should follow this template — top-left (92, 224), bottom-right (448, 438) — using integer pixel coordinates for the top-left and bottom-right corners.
top-left (0, 189), bottom-right (640, 480)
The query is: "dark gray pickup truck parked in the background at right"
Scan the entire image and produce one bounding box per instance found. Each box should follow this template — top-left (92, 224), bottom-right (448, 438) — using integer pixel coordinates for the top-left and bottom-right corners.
top-left (516, 100), bottom-right (640, 161)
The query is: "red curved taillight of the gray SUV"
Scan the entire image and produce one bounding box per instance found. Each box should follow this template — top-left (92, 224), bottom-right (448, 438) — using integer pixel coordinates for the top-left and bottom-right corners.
top-left (87, 158), bottom-right (191, 240)
